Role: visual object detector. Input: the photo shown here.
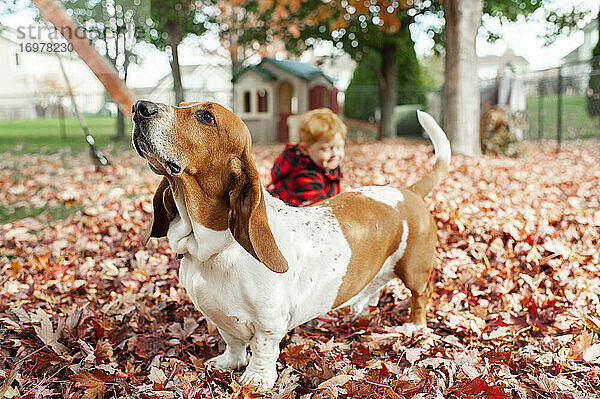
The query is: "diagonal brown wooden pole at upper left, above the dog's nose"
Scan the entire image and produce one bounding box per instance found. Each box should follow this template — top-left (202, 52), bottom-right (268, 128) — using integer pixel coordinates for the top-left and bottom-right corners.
top-left (32, 0), bottom-right (133, 118)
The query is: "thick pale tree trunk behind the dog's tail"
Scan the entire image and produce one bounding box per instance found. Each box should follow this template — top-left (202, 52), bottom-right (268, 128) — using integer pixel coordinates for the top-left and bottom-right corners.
top-left (444, 0), bottom-right (483, 156)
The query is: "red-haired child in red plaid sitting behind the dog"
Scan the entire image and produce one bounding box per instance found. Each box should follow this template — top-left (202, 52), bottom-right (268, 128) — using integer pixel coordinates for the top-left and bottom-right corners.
top-left (268, 108), bottom-right (347, 206)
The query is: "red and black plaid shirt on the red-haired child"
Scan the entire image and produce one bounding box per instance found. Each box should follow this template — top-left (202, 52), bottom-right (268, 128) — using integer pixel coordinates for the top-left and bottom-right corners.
top-left (268, 143), bottom-right (342, 206)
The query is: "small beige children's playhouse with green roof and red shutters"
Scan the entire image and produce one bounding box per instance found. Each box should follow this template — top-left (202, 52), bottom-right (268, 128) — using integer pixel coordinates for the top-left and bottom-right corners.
top-left (231, 57), bottom-right (339, 143)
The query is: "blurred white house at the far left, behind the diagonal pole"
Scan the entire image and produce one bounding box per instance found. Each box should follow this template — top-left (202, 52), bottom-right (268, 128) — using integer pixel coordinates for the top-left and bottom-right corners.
top-left (0, 26), bottom-right (104, 119)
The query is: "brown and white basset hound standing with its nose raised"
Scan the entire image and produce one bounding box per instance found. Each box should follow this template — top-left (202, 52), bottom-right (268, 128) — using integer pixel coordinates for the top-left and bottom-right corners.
top-left (132, 100), bottom-right (450, 389)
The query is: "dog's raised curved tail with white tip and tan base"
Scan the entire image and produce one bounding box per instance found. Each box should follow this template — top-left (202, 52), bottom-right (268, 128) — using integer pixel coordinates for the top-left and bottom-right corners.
top-left (410, 111), bottom-right (452, 197)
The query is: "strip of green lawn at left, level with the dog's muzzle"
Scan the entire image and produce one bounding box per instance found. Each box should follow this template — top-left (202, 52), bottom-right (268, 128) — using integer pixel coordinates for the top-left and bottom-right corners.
top-left (0, 115), bottom-right (131, 154)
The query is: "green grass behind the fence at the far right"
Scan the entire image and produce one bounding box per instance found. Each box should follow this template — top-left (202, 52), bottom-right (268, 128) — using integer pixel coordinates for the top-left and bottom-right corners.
top-left (525, 95), bottom-right (600, 140)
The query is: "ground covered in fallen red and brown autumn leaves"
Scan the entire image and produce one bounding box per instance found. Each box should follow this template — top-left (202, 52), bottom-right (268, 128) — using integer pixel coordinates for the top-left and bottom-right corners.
top-left (0, 141), bottom-right (600, 399)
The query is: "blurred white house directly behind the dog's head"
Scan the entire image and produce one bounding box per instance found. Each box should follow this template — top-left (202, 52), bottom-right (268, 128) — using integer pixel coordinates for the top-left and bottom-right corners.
top-left (144, 64), bottom-right (233, 108)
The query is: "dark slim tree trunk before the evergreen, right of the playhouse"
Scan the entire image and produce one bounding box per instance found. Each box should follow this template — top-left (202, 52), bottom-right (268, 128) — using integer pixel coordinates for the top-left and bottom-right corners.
top-left (377, 42), bottom-right (398, 139)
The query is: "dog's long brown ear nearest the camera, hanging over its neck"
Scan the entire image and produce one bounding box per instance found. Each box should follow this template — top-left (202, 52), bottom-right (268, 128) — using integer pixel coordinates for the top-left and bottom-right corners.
top-left (228, 150), bottom-right (288, 273)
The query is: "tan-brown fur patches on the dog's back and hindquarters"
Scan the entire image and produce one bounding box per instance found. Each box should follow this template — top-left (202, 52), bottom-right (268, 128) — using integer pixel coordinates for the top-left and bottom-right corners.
top-left (325, 190), bottom-right (436, 314)
